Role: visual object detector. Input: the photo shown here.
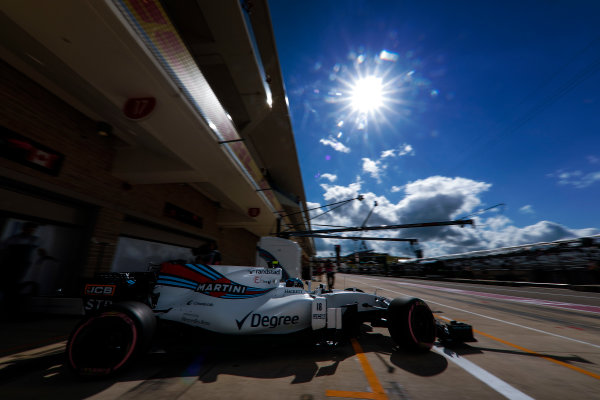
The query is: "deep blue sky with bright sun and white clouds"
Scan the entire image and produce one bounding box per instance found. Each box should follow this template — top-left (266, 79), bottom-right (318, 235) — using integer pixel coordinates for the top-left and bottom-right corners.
top-left (269, 0), bottom-right (600, 256)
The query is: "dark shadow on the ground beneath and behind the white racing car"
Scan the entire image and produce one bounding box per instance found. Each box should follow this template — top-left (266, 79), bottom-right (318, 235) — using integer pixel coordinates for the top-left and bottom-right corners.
top-left (0, 326), bottom-right (447, 400)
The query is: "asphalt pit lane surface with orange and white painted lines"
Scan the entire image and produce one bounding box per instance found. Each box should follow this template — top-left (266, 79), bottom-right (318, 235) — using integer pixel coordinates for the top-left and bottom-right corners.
top-left (0, 274), bottom-right (600, 400)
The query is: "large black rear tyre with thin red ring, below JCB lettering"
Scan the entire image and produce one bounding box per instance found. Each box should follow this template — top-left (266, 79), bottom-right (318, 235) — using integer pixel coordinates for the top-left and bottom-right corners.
top-left (66, 301), bottom-right (156, 377)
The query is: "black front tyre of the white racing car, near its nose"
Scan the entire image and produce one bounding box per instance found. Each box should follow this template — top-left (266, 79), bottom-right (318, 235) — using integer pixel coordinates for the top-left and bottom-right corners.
top-left (387, 297), bottom-right (435, 351)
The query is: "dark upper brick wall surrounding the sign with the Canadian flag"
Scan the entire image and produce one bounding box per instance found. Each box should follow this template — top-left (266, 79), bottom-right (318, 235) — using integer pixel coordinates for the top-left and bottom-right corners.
top-left (0, 62), bottom-right (122, 206)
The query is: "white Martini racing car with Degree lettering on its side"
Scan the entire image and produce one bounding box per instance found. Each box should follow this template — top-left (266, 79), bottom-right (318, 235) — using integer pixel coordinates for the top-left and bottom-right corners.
top-left (66, 238), bottom-right (472, 377)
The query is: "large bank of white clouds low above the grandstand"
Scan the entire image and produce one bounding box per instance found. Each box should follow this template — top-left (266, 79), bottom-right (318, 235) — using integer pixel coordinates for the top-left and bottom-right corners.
top-left (309, 176), bottom-right (600, 257)
